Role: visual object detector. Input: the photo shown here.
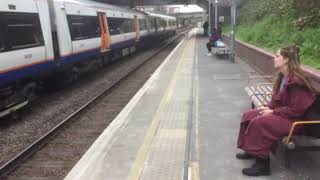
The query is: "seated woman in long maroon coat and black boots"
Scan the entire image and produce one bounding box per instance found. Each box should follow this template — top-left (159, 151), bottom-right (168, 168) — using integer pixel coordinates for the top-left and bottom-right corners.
top-left (236, 45), bottom-right (317, 176)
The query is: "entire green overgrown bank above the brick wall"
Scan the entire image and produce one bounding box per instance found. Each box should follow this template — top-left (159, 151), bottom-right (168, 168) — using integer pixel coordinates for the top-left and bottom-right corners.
top-left (223, 0), bottom-right (320, 69)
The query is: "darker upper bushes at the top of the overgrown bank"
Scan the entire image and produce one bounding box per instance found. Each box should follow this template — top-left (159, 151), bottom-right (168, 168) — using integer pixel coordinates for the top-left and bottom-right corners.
top-left (237, 0), bottom-right (320, 28)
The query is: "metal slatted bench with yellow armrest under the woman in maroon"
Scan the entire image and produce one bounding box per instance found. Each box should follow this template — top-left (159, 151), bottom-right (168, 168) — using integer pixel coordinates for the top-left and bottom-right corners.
top-left (245, 76), bottom-right (320, 168)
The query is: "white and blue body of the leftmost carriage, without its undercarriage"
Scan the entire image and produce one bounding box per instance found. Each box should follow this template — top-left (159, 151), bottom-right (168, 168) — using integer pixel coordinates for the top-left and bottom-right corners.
top-left (0, 0), bottom-right (54, 86)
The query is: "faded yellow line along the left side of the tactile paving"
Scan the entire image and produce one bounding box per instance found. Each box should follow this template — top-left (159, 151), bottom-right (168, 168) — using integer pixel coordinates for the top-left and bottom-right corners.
top-left (128, 37), bottom-right (186, 180)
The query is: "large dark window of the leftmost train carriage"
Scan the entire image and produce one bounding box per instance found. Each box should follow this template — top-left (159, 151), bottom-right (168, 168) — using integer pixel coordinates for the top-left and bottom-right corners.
top-left (0, 13), bottom-right (44, 51)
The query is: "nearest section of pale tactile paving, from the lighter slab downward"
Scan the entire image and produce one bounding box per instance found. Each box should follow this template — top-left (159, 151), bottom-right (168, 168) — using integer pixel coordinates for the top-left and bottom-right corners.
top-left (141, 129), bottom-right (187, 180)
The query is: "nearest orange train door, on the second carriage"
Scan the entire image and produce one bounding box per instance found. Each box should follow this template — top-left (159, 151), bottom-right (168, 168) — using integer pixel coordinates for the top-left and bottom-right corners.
top-left (98, 12), bottom-right (110, 52)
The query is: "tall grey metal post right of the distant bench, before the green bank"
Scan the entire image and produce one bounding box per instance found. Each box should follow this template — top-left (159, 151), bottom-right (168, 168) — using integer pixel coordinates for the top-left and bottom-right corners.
top-left (230, 0), bottom-right (236, 63)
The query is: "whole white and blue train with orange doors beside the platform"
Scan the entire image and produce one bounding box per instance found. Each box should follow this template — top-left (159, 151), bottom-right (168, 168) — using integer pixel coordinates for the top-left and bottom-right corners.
top-left (0, 0), bottom-right (177, 118)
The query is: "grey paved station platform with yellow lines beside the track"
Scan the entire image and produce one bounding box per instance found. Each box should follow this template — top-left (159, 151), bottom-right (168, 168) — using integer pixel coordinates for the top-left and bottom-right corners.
top-left (65, 29), bottom-right (320, 180)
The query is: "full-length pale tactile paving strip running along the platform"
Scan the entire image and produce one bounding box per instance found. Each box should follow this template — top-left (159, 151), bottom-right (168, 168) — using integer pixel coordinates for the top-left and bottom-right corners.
top-left (140, 34), bottom-right (195, 180)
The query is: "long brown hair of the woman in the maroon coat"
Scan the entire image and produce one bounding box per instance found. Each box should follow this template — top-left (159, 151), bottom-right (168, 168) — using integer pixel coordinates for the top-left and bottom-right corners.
top-left (273, 45), bottom-right (318, 94)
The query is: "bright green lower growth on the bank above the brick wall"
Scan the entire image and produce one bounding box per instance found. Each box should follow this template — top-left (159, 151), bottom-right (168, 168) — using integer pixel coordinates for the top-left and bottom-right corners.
top-left (224, 15), bottom-right (320, 69)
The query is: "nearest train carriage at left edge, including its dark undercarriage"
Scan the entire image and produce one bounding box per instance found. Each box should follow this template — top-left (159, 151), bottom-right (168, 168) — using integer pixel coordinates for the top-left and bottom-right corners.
top-left (0, 0), bottom-right (55, 117)
